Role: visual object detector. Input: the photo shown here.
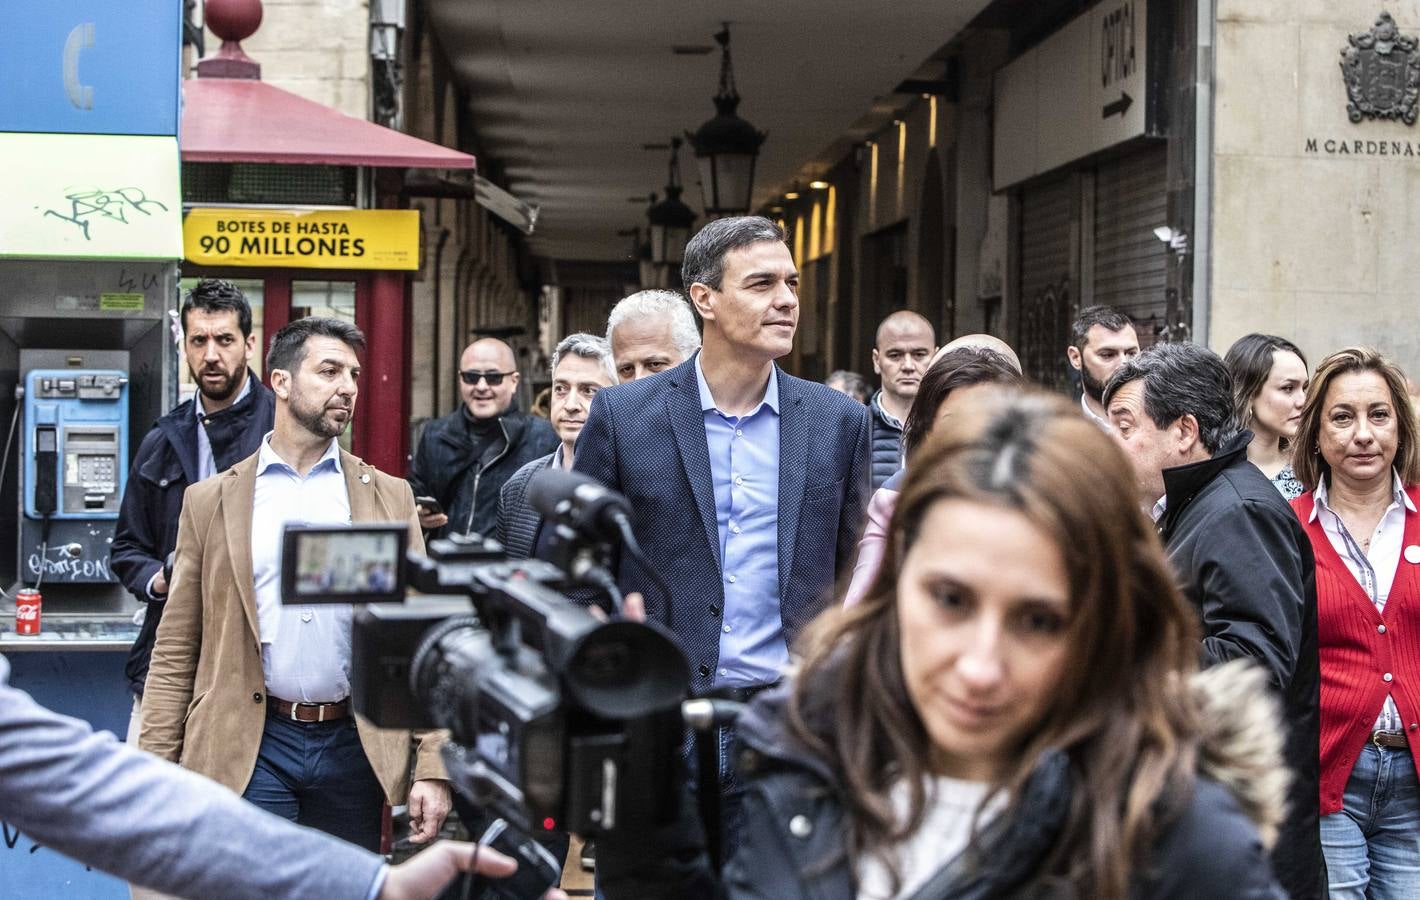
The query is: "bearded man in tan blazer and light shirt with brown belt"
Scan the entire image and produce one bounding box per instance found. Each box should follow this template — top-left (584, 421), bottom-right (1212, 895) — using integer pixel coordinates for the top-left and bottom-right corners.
top-left (139, 318), bottom-right (450, 849)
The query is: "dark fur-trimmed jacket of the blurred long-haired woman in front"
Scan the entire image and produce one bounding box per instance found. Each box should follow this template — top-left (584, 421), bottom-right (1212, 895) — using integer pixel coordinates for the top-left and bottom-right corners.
top-left (596, 655), bottom-right (1284, 900)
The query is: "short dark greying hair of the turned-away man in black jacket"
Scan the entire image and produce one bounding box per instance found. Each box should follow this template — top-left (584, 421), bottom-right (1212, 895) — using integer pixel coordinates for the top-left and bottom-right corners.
top-left (1105, 344), bottom-right (1240, 454)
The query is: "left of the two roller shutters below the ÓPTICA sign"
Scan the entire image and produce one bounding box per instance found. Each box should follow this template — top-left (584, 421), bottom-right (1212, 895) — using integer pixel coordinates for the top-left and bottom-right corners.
top-left (1017, 176), bottom-right (1076, 389)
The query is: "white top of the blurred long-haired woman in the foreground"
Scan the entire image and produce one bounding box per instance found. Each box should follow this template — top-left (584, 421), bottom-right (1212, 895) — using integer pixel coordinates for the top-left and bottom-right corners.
top-left (858, 776), bottom-right (1005, 900)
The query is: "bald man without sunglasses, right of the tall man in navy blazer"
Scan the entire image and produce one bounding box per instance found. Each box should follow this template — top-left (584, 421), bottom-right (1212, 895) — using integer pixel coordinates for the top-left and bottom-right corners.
top-left (868, 309), bottom-right (937, 490)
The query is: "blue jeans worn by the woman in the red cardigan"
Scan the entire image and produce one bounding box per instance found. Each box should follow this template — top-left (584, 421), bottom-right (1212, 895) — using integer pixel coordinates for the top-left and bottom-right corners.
top-left (1322, 744), bottom-right (1420, 900)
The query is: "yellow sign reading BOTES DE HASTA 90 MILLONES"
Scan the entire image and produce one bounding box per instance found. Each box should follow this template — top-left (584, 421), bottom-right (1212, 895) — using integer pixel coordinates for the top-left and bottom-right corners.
top-left (182, 209), bottom-right (419, 270)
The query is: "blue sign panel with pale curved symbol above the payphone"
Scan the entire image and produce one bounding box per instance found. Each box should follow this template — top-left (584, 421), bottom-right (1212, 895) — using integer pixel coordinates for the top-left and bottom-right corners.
top-left (0, 0), bottom-right (182, 135)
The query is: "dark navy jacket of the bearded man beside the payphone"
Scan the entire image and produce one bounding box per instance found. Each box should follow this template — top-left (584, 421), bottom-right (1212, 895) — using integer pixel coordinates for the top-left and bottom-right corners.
top-left (111, 369), bottom-right (275, 696)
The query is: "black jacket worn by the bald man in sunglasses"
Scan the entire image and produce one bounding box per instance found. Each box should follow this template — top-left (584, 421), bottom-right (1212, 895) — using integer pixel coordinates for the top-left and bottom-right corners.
top-left (409, 402), bottom-right (561, 538)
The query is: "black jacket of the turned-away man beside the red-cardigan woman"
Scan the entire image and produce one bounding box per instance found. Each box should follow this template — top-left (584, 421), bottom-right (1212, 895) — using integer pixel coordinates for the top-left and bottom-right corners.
top-left (1159, 432), bottom-right (1326, 900)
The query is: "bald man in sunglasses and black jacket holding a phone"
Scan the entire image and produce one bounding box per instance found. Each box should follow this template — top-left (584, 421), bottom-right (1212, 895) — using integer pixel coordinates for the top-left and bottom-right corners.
top-left (409, 338), bottom-right (559, 537)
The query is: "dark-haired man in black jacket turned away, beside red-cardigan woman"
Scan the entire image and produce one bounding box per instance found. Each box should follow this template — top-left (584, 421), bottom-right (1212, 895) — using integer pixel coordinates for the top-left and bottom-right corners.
top-left (1105, 344), bottom-right (1326, 899)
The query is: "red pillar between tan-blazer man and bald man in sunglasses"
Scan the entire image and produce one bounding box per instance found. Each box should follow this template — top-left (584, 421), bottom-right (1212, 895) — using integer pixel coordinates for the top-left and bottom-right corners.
top-left (354, 271), bottom-right (409, 477)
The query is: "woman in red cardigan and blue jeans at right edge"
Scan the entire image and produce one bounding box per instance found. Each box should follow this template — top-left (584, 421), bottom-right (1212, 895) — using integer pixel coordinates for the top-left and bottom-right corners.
top-left (1292, 348), bottom-right (1420, 900)
